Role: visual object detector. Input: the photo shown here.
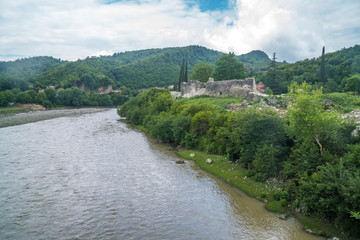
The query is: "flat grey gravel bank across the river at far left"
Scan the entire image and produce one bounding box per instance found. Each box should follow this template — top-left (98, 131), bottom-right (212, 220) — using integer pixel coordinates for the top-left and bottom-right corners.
top-left (0, 108), bottom-right (106, 128)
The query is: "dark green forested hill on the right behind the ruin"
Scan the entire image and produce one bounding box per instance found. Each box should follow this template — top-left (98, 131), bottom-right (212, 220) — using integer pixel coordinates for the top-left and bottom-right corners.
top-left (257, 45), bottom-right (360, 94)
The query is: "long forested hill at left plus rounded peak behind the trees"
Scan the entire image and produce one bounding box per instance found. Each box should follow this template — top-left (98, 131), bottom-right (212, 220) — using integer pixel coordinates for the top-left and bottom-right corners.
top-left (0, 46), bottom-right (270, 90)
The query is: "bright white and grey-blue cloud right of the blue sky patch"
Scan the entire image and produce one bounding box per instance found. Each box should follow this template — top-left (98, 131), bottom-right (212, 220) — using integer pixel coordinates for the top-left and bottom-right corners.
top-left (207, 0), bottom-right (360, 61)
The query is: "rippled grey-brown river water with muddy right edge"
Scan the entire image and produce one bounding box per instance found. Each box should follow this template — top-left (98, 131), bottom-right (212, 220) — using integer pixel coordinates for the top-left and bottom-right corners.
top-left (0, 109), bottom-right (321, 240)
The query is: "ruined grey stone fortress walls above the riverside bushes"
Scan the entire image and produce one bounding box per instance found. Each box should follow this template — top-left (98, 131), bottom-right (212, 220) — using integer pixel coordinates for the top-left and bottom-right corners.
top-left (181, 78), bottom-right (265, 100)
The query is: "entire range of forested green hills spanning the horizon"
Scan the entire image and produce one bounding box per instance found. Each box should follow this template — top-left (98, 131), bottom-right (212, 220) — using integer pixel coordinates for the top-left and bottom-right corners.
top-left (0, 45), bottom-right (360, 94)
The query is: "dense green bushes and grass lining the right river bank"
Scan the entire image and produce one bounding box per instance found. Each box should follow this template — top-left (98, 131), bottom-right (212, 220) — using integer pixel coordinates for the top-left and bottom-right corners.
top-left (118, 83), bottom-right (360, 238)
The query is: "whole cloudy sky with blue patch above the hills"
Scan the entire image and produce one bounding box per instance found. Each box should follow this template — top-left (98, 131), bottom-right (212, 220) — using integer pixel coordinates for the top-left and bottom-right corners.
top-left (0, 0), bottom-right (360, 62)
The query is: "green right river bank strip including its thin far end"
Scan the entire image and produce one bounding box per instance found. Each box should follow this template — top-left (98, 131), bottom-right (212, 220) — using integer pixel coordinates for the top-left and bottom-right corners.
top-left (124, 121), bottom-right (338, 240)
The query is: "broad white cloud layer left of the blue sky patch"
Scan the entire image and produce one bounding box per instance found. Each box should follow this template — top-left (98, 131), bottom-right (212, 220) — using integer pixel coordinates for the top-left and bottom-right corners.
top-left (0, 0), bottom-right (228, 59)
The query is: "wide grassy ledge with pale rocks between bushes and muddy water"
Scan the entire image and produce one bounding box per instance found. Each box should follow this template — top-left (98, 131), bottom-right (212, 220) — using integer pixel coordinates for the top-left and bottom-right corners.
top-left (178, 150), bottom-right (347, 239)
